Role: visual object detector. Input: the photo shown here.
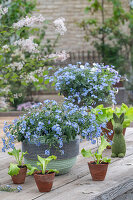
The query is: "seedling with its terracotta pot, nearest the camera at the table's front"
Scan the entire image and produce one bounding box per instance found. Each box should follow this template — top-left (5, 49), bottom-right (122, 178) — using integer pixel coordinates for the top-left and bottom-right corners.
top-left (27, 155), bottom-right (59, 192)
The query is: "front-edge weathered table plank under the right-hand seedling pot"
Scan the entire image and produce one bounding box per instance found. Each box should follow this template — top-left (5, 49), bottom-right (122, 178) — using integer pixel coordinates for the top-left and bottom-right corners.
top-left (31, 155), bottom-right (133, 200)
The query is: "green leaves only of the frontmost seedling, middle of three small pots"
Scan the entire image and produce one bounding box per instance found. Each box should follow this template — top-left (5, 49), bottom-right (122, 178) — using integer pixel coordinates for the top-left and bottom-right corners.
top-left (27, 155), bottom-right (59, 175)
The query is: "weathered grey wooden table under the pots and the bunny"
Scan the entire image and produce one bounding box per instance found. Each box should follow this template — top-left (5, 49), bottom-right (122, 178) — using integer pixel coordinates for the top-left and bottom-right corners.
top-left (0, 128), bottom-right (133, 200)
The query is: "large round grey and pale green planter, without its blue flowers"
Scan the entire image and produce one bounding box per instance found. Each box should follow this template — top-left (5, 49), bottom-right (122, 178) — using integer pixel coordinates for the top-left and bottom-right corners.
top-left (22, 137), bottom-right (80, 175)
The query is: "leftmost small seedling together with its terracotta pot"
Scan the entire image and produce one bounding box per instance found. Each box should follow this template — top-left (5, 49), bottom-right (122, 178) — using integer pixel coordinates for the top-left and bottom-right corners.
top-left (8, 148), bottom-right (27, 184)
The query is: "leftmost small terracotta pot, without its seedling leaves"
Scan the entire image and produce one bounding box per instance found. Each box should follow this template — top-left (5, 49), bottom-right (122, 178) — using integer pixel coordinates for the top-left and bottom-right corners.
top-left (12, 166), bottom-right (27, 184)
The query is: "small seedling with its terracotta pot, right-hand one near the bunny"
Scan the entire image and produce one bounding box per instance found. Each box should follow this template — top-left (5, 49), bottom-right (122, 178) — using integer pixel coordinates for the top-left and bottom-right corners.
top-left (81, 136), bottom-right (111, 181)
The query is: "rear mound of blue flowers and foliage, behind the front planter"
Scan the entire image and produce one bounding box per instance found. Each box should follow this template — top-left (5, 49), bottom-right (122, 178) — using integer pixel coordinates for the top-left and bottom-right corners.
top-left (45, 63), bottom-right (120, 106)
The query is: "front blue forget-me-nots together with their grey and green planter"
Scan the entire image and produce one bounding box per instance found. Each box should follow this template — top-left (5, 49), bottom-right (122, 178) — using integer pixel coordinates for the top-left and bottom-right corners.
top-left (3, 100), bottom-right (105, 174)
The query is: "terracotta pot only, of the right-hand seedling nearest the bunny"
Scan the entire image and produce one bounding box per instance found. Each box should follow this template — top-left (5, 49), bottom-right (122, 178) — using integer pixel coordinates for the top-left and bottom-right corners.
top-left (88, 161), bottom-right (108, 181)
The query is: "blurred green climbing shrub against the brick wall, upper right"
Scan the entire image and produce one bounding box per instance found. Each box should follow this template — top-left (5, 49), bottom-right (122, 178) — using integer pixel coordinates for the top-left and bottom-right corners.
top-left (79, 0), bottom-right (133, 78)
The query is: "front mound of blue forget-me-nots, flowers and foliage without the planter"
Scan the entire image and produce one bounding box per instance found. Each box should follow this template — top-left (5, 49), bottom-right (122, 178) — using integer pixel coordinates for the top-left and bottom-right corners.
top-left (2, 100), bottom-right (107, 155)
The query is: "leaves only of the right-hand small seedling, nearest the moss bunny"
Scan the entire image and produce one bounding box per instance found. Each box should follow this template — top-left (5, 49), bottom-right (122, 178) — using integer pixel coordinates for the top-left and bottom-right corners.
top-left (81, 136), bottom-right (111, 164)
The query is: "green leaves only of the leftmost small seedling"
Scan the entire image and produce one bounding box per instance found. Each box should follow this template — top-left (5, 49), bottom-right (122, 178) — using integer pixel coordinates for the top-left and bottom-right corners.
top-left (8, 148), bottom-right (27, 176)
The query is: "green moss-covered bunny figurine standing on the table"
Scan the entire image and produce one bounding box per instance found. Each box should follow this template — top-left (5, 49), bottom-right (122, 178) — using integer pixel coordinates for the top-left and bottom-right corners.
top-left (111, 113), bottom-right (126, 158)
